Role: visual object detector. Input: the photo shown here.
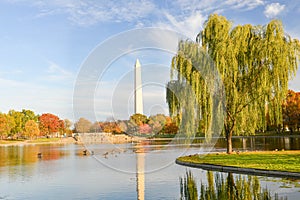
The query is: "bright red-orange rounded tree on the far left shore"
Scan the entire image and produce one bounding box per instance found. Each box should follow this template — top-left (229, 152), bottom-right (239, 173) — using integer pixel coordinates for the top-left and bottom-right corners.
top-left (39, 113), bottom-right (61, 136)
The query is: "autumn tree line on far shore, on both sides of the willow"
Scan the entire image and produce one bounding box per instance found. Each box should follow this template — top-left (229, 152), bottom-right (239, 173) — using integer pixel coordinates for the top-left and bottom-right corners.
top-left (0, 90), bottom-right (300, 139)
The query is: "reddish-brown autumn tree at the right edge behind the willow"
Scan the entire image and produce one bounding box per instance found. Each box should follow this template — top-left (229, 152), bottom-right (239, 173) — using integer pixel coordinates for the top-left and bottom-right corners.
top-left (282, 90), bottom-right (300, 132)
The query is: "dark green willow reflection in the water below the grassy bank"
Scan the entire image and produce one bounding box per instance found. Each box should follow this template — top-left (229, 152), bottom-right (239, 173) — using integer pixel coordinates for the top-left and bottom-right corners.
top-left (180, 171), bottom-right (287, 200)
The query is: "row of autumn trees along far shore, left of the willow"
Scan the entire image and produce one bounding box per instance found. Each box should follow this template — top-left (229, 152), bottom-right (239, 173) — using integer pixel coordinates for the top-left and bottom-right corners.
top-left (0, 109), bottom-right (178, 139)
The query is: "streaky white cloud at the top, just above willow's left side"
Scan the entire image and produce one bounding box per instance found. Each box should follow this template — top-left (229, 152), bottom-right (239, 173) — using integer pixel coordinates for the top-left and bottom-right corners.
top-left (155, 0), bottom-right (264, 40)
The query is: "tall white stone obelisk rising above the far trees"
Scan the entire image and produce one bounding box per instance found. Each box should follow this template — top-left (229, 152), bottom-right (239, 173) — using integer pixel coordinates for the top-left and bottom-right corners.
top-left (134, 59), bottom-right (143, 114)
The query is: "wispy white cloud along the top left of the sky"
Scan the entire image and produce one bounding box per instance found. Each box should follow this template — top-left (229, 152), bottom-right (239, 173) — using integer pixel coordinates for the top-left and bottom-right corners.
top-left (14, 0), bottom-right (155, 26)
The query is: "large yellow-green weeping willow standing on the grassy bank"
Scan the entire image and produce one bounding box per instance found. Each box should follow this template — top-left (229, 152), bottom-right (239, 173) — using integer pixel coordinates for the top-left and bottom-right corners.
top-left (167, 14), bottom-right (300, 153)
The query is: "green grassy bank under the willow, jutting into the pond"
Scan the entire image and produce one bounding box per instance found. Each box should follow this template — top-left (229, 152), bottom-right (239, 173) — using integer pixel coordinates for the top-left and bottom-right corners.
top-left (178, 151), bottom-right (300, 173)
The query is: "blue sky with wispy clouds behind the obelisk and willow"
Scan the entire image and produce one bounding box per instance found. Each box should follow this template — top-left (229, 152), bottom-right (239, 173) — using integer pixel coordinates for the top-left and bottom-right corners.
top-left (0, 0), bottom-right (300, 120)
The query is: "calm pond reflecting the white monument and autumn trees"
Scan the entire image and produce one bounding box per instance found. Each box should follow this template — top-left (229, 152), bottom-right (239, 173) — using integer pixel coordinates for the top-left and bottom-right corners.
top-left (0, 137), bottom-right (300, 200)
